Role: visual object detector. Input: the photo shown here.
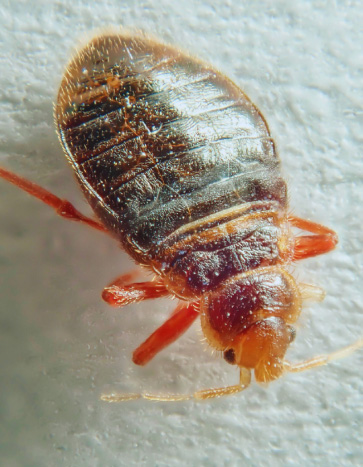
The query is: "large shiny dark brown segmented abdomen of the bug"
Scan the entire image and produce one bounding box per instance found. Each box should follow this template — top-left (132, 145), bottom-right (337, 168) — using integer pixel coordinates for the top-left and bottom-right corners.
top-left (56, 36), bottom-right (286, 262)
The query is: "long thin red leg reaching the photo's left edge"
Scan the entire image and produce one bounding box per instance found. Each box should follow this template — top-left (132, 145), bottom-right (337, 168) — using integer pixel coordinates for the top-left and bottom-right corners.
top-left (0, 167), bottom-right (107, 232)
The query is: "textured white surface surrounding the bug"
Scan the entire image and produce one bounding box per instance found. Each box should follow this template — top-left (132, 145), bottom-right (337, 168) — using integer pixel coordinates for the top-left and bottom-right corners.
top-left (0, 0), bottom-right (363, 467)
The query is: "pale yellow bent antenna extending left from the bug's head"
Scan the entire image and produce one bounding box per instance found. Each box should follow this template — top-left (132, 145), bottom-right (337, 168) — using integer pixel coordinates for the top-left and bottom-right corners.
top-left (101, 368), bottom-right (251, 402)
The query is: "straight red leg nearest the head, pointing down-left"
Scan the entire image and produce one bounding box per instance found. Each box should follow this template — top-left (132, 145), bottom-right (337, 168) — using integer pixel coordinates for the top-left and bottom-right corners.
top-left (132, 303), bottom-right (199, 365)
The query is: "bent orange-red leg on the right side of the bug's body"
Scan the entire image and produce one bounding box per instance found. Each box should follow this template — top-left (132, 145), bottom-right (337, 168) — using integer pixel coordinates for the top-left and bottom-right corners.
top-left (288, 216), bottom-right (338, 261)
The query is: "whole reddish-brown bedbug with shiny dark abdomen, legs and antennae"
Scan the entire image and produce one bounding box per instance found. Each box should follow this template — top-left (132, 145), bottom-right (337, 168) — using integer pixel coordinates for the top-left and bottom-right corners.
top-left (0, 34), bottom-right (362, 402)
